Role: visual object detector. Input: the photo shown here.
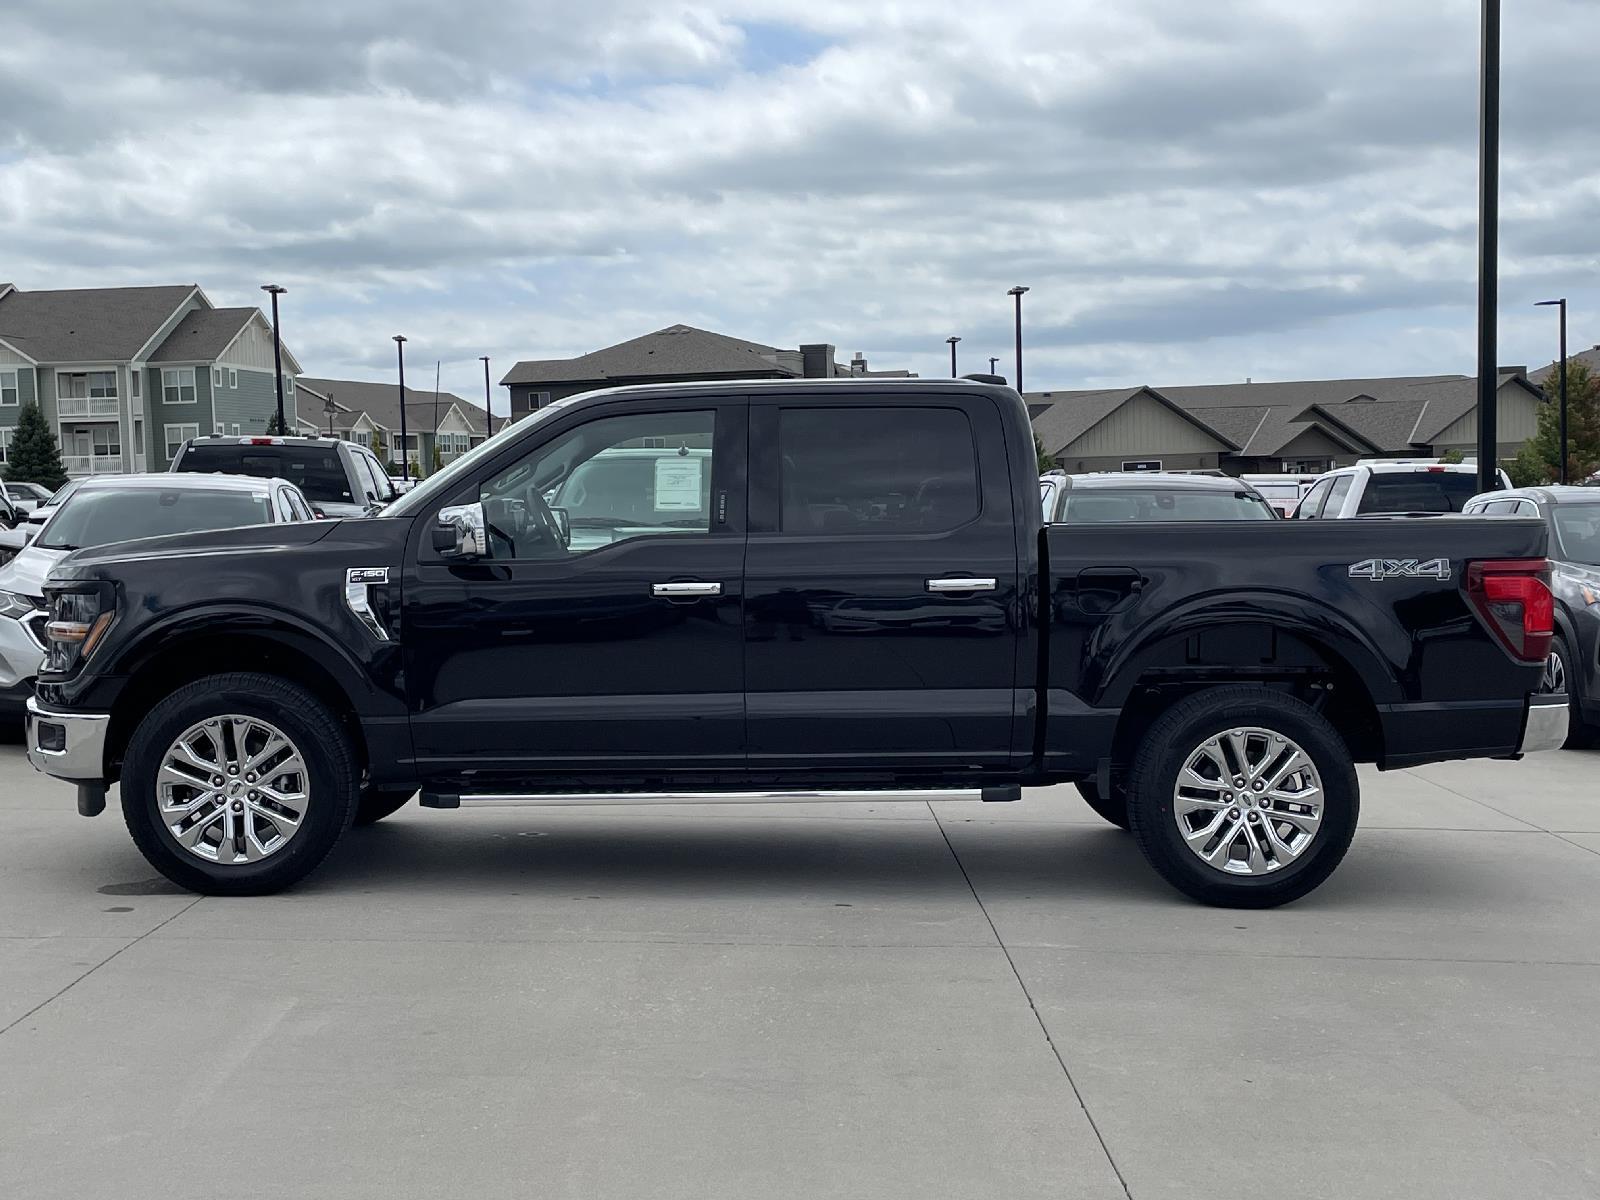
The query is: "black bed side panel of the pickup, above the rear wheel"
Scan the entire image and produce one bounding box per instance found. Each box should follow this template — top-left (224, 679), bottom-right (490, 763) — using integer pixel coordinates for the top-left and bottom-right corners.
top-left (1042, 517), bottom-right (1547, 765)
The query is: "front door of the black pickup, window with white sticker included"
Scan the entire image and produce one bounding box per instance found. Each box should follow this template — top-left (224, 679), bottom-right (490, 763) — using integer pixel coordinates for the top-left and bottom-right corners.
top-left (403, 397), bottom-right (746, 778)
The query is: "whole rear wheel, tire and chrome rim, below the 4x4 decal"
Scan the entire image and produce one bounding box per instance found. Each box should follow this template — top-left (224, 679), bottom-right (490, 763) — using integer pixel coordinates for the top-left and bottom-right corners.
top-left (1128, 685), bottom-right (1360, 909)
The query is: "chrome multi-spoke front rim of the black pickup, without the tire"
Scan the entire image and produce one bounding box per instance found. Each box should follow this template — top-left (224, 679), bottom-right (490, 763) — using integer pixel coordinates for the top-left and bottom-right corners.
top-left (155, 714), bottom-right (310, 864)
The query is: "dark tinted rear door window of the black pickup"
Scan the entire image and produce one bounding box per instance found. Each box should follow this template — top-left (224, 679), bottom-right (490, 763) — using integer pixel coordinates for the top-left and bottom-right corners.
top-left (778, 408), bottom-right (978, 534)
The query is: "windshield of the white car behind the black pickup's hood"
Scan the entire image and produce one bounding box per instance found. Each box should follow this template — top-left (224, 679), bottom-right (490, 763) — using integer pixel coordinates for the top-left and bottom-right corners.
top-left (35, 485), bottom-right (272, 550)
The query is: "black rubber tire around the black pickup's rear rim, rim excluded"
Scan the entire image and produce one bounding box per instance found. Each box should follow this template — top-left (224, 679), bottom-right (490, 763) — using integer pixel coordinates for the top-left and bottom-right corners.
top-left (1128, 685), bottom-right (1362, 909)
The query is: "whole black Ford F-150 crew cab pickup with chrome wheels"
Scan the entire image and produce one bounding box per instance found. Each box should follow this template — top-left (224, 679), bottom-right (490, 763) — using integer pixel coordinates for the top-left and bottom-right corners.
top-left (29, 379), bottom-right (1568, 907)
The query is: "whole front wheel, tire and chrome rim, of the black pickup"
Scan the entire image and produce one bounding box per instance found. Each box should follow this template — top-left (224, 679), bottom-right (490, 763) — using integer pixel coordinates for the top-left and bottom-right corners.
top-left (122, 672), bottom-right (358, 896)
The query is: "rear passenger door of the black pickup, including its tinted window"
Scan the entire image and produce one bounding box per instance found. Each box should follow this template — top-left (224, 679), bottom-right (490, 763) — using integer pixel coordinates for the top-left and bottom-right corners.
top-left (744, 384), bottom-right (1034, 781)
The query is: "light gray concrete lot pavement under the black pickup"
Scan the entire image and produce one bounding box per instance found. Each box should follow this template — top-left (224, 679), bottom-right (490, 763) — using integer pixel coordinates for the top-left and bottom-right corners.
top-left (0, 744), bottom-right (1600, 1200)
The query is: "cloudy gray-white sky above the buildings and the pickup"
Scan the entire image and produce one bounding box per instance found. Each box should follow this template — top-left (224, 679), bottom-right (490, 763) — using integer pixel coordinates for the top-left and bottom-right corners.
top-left (0, 0), bottom-right (1600, 403)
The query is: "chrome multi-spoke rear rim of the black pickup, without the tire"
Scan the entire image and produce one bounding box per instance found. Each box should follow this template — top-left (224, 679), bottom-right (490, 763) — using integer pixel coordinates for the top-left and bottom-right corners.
top-left (1173, 726), bottom-right (1323, 875)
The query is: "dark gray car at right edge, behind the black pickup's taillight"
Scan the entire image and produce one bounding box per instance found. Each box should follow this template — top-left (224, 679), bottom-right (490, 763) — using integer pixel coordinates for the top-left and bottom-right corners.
top-left (1462, 486), bottom-right (1600, 739)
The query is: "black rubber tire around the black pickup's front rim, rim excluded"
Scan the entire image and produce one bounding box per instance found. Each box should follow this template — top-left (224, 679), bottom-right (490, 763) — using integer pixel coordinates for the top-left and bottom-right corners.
top-left (122, 672), bottom-right (360, 896)
